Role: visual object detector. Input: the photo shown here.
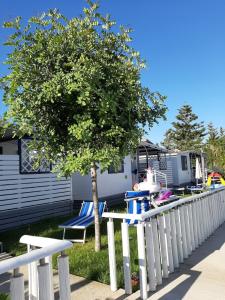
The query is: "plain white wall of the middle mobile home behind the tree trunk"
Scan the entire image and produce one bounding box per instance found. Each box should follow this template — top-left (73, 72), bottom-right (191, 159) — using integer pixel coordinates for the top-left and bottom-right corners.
top-left (72, 156), bottom-right (132, 200)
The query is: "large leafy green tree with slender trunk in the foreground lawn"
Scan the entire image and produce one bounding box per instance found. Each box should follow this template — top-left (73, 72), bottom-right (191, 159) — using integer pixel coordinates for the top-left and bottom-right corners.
top-left (2, 1), bottom-right (166, 251)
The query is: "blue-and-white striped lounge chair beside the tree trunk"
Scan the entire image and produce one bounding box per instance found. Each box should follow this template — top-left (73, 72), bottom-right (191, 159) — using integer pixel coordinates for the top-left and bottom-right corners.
top-left (59, 201), bottom-right (106, 244)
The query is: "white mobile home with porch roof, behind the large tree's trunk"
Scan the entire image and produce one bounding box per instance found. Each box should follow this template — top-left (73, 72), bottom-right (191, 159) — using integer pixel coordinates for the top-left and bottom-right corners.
top-left (72, 140), bottom-right (173, 206)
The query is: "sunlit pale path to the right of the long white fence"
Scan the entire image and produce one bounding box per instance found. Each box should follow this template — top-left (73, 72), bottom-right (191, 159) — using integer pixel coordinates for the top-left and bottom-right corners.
top-left (127, 223), bottom-right (225, 300)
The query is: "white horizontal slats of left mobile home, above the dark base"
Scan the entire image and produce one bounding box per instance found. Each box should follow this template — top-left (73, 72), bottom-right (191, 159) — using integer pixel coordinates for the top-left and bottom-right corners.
top-left (0, 155), bottom-right (71, 211)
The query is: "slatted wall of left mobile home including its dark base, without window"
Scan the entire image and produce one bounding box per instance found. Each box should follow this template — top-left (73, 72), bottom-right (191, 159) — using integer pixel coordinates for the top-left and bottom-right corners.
top-left (0, 155), bottom-right (72, 231)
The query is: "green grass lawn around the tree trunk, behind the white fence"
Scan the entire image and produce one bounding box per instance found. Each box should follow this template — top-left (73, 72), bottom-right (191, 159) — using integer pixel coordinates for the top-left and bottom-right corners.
top-left (0, 209), bottom-right (138, 287)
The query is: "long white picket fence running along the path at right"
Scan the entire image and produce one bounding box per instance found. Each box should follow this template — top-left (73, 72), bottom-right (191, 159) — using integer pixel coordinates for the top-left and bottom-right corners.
top-left (103, 188), bottom-right (225, 299)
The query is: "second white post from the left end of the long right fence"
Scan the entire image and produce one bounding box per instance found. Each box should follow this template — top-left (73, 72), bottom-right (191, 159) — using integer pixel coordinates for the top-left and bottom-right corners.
top-left (121, 220), bottom-right (132, 294)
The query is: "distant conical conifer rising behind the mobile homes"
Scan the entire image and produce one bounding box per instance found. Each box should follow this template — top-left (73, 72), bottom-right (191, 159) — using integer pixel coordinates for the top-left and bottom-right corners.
top-left (162, 105), bottom-right (206, 151)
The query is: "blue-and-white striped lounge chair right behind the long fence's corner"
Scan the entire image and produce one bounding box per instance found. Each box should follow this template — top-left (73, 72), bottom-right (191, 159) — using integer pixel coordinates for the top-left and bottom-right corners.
top-left (125, 191), bottom-right (150, 225)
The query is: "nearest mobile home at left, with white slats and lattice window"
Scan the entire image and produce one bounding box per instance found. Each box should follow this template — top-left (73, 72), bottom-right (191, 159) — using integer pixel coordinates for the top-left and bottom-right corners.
top-left (0, 136), bottom-right (73, 231)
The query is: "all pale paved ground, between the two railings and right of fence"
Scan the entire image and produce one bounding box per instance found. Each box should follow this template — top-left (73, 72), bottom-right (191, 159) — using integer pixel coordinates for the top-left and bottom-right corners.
top-left (0, 224), bottom-right (225, 300)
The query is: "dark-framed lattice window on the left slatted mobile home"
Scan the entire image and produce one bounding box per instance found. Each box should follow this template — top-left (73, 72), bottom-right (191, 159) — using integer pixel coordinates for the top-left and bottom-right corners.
top-left (19, 139), bottom-right (51, 174)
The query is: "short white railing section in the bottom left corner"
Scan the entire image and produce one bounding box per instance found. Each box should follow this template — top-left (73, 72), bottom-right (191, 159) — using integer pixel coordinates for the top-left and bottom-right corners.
top-left (0, 235), bottom-right (72, 300)
